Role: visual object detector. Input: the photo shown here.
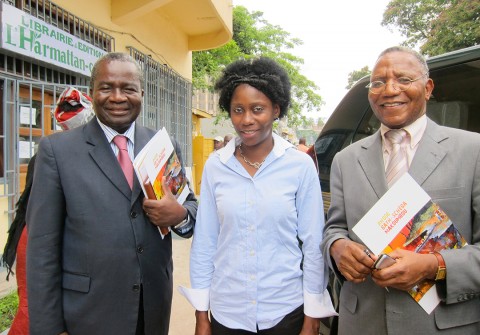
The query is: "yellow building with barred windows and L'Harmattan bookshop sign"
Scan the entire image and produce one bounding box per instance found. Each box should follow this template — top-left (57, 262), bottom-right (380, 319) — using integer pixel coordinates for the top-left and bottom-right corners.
top-left (0, 0), bottom-right (232, 245)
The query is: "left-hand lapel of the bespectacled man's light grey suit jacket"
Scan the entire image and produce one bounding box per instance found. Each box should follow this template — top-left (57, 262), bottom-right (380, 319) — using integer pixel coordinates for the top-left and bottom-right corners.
top-left (358, 131), bottom-right (387, 199)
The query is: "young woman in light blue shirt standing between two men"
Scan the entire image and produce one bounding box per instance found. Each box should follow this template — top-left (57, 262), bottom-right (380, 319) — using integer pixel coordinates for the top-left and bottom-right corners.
top-left (180, 58), bottom-right (335, 335)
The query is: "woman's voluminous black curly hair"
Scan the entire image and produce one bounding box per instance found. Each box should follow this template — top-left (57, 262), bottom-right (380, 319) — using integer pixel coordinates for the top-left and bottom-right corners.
top-left (215, 57), bottom-right (291, 118)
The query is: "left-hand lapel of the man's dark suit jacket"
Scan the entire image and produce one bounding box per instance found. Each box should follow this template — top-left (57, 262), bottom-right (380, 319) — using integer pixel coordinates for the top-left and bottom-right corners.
top-left (85, 118), bottom-right (136, 199)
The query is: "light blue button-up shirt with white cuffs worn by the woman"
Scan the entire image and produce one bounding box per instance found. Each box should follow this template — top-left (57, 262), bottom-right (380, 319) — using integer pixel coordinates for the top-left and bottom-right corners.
top-left (181, 134), bottom-right (335, 332)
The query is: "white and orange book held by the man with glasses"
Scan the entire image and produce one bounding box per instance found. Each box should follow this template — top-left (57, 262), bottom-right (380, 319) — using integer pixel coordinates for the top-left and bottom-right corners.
top-left (353, 173), bottom-right (467, 314)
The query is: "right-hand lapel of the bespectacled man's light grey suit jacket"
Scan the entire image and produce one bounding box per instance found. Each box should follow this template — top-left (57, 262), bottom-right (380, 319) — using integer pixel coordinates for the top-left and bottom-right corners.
top-left (408, 119), bottom-right (447, 185)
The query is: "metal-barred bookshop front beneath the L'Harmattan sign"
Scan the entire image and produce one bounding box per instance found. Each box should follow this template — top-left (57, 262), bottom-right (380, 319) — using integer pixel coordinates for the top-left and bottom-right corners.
top-left (0, 76), bottom-right (88, 228)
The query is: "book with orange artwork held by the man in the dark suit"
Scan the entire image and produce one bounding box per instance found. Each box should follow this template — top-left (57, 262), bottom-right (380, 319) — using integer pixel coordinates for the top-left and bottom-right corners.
top-left (133, 128), bottom-right (190, 235)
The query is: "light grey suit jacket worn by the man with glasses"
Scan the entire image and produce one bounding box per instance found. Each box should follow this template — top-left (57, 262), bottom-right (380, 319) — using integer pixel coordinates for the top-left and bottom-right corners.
top-left (322, 120), bottom-right (480, 335)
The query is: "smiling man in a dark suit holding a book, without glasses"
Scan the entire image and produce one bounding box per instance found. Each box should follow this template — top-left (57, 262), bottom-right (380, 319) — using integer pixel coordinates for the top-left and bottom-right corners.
top-left (26, 53), bottom-right (197, 335)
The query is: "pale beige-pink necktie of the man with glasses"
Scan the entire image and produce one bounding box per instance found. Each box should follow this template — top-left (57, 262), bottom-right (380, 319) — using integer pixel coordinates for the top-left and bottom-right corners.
top-left (385, 129), bottom-right (408, 188)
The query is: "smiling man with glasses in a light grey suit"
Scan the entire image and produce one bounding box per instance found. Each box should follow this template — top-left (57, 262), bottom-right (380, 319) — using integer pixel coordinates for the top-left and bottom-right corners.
top-left (322, 47), bottom-right (480, 335)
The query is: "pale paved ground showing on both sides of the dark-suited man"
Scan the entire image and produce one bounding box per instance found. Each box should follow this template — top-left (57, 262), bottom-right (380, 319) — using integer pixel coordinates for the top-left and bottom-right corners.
top-left (0, 234), bottom-right (195, 335)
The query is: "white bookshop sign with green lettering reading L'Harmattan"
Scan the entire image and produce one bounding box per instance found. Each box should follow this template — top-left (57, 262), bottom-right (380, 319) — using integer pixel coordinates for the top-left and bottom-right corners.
top-left (0, 3), bottom-right (106, 76)
